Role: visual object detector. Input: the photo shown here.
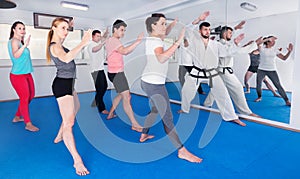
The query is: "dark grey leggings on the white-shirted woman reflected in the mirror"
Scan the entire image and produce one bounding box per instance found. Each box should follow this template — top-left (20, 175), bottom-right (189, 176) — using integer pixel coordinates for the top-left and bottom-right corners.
top-left (256, 69), bottom-right (289, 101)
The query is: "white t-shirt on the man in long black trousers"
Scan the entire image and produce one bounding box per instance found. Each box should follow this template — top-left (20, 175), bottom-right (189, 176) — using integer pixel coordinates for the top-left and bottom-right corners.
top-left (87, 41), bottom-right (105, 72)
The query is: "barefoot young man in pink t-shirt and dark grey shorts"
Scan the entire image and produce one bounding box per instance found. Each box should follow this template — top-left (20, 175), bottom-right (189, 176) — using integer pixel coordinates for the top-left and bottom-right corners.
top-left (106, 19), bottom-right (144, 132)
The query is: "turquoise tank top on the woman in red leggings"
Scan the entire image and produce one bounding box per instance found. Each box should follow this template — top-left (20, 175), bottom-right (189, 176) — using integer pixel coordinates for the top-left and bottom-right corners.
top-left (7, 40), bottom-right (33, 75)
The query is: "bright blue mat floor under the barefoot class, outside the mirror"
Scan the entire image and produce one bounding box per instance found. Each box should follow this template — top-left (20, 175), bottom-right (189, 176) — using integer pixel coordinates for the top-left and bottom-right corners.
top-left (0, 90), bottom-right (300, 179)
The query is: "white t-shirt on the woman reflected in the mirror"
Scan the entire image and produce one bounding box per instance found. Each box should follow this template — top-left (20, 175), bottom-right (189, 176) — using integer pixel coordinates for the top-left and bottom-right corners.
top-left (258, 47), bottom-right (279, 71)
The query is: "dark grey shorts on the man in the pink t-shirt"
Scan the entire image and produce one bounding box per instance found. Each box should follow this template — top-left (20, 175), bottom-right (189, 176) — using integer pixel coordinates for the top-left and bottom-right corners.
top-left (108, 72), bottom-right (129, 93)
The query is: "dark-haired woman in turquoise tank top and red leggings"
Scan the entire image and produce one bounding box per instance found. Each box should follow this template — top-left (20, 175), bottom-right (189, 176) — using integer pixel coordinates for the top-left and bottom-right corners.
top-left (8, 21), bottom-right (39, 132)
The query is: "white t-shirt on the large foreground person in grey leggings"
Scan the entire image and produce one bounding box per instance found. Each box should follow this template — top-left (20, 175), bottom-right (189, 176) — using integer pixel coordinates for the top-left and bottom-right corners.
top-left (141, 37), bottom-right (169, 84)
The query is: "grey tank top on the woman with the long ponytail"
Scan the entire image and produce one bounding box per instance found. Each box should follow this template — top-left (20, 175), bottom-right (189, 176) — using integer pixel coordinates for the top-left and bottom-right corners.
top-left (48, 42), bottom-right (76, 78)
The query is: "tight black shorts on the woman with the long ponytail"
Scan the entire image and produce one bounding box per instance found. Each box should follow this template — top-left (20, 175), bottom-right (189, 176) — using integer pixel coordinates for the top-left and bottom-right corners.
top-left (52, 77), bottom-right (75, 98)
